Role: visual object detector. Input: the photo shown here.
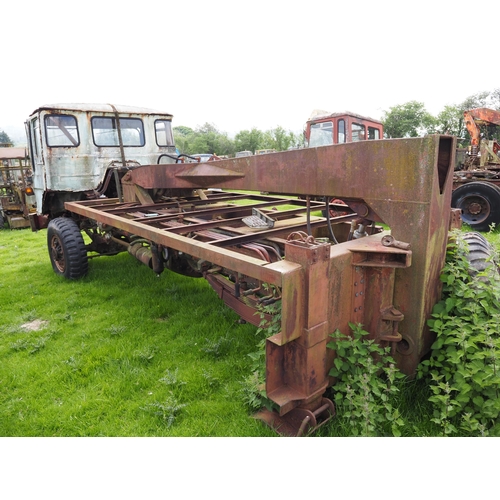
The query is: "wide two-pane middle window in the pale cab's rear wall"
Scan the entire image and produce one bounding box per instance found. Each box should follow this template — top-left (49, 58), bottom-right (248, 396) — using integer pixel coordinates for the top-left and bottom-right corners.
top-left (91, 116), bottom-right (146, 147)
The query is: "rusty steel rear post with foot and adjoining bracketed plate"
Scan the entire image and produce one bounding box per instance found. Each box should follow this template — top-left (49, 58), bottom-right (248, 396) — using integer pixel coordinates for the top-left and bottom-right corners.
top-left (258, 234), bottom-right (411, 435)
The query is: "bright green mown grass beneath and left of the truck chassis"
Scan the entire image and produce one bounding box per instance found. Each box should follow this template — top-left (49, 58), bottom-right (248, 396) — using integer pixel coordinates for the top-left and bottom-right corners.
top-left (0, 225), bottom-right (500, 436)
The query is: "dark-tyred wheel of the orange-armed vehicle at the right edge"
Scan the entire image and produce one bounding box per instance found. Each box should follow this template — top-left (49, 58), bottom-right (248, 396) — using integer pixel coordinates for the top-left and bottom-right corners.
top-left (451, 182), bottom-right (500, 231)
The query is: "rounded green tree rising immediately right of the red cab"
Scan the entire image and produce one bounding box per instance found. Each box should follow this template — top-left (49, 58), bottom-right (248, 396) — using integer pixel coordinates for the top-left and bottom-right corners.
top-left (382, 101), bottom-right (436, 138)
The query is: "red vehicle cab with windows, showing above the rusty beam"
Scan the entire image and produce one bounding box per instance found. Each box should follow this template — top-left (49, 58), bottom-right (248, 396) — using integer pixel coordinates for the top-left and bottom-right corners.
top-left (304, 110), bottom-right (384, 148)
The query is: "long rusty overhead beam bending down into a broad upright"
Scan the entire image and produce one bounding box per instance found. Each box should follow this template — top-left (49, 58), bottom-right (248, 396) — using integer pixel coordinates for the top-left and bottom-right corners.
top-left (143, 136), bottom-right (456, 374)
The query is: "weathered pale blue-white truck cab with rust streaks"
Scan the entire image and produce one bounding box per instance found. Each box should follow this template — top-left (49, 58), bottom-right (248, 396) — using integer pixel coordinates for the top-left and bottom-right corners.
top-left (26, 104), bottom-right (177, 229)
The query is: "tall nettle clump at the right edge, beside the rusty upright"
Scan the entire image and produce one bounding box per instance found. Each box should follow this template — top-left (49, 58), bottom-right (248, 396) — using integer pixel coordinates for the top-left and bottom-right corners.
top-left (418, 233), bottom-right (500, 436)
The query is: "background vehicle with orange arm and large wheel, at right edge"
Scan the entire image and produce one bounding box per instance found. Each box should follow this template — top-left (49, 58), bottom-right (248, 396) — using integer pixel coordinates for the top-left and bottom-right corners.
top-left (451, 108), bottom-right (500, 231)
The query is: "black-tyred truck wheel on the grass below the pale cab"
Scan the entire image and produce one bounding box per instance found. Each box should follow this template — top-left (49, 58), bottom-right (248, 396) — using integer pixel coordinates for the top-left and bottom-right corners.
top-left (47, 217), bottom-right (88, 279)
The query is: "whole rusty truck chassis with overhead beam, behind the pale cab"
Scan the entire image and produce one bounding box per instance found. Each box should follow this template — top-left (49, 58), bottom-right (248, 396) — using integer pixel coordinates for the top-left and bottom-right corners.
top-left (59, 136), bottom-right (455, 435)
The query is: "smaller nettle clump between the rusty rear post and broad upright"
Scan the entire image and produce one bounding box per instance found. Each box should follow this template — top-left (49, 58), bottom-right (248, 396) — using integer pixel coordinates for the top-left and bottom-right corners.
top-left (327, 323), bottom-right (404, 436)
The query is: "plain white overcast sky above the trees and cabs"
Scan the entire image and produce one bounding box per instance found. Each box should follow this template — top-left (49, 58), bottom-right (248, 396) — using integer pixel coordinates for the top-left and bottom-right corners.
top-left (0, 0), bottom-right (500, 141)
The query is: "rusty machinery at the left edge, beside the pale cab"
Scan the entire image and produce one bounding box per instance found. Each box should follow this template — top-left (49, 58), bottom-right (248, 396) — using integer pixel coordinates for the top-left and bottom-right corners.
top-left (0, 147), bottom-right (35, 229)
